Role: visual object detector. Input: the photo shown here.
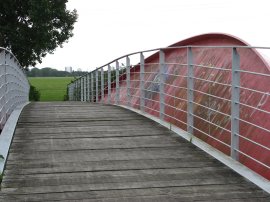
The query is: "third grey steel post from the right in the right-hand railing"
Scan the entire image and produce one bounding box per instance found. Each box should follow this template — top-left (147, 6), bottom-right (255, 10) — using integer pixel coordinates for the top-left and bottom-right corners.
top-left (159, 50), bottom-right (165, 120)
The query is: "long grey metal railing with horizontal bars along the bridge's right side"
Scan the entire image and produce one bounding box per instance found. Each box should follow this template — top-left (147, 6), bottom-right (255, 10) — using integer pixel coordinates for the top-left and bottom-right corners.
top-left (68, 46), bottom-right (270, 179)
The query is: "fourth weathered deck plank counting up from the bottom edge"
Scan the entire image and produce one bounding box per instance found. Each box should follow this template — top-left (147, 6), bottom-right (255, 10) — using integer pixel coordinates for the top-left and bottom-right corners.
top-left (5, 158), bottom-right (222, 175)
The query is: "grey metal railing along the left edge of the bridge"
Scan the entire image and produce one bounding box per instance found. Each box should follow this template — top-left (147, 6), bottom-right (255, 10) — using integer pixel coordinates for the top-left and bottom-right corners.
top-left (0, 48), bottom-right (29, 130)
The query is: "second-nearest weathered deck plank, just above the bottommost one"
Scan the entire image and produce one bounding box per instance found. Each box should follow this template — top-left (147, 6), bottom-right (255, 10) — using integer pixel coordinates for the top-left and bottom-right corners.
top-left (1, 176), bottom-right (254, 195)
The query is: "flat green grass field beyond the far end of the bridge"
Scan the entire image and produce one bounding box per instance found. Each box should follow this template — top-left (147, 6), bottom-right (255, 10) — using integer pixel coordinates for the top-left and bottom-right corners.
top-left (28, 77), bottom-right (73, 101)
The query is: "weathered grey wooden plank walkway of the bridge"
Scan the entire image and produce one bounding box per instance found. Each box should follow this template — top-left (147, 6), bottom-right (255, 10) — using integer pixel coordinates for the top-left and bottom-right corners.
top-left (0, 102), bottom-right (270, 202)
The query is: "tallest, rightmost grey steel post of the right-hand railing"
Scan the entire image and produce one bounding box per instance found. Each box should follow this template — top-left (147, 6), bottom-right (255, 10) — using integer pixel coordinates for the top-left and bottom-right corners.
top-left (231, 48), bottom-right (240, 161)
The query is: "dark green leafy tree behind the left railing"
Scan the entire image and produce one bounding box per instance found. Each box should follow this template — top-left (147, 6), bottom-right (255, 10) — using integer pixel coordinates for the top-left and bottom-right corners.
top-left (0, 0), bottom-right (77, 67)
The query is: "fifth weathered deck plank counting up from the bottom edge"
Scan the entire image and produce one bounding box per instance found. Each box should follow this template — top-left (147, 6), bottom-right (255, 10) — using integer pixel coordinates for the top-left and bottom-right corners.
top-left (9, 147), bottom-right (208, 163)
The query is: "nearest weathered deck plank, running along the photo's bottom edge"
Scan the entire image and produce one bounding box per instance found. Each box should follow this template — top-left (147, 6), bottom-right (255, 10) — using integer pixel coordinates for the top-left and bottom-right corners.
top-left (1, 184), bottom-right (269, 201)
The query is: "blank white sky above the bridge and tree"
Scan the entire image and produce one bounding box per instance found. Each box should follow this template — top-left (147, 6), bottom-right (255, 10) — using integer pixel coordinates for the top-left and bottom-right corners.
top-left (37, 0), bottom-right (270, 71)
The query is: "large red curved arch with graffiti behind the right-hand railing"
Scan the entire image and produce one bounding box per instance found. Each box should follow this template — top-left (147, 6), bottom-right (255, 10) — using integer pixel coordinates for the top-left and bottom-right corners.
top-left (108, 33), bottom-right (270, 179)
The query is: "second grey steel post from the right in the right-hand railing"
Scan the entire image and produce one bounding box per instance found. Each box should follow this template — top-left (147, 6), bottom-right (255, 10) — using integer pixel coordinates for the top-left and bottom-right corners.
top-left (187, 47), bottom-right (194, 134)
